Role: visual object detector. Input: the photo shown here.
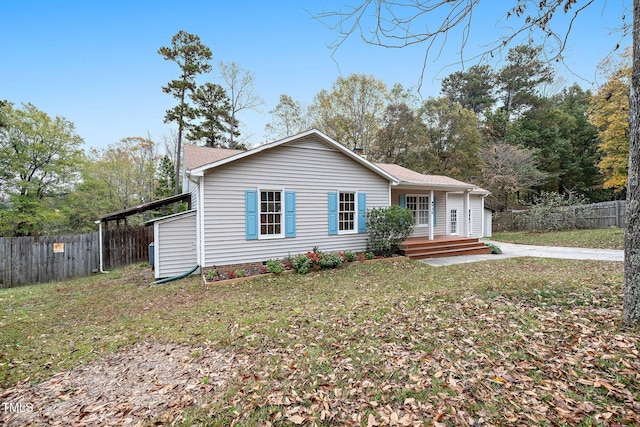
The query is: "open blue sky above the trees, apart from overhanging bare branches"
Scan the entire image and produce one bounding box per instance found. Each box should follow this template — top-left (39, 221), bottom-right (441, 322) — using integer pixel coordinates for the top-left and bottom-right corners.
top-left (0, 0), bottom-right (630, 151)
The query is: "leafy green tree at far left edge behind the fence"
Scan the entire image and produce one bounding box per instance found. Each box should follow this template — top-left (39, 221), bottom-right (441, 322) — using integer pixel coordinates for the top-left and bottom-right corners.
top-left (0, 103), bottom-right (83, 236)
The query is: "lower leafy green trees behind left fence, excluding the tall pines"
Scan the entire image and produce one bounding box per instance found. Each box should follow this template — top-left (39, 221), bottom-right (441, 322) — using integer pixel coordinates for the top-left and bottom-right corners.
top-left (0, 102), bottom-right (174, 237)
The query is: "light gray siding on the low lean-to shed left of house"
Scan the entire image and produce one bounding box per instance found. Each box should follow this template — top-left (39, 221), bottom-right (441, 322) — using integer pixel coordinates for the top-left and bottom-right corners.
top-left (154, 212), bottom-right (198, 278)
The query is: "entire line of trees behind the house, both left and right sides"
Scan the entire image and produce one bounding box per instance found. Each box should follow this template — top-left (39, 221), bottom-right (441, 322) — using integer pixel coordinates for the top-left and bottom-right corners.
top-left (0, 32), bottom-right (631, 236)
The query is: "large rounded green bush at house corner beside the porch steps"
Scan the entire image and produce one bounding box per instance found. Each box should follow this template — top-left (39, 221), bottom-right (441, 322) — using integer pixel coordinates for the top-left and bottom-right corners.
top-left (367, 205), bottom-right (414, 256)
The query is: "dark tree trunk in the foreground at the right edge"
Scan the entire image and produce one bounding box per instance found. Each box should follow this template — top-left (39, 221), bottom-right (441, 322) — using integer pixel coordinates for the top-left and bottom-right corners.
top-left (623, 0), bottom-right (640, 324)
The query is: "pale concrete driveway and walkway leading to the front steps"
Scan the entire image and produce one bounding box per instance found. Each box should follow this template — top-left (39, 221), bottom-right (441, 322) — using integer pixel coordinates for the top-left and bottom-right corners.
top-left (421, 239), bottom-right (624, 267)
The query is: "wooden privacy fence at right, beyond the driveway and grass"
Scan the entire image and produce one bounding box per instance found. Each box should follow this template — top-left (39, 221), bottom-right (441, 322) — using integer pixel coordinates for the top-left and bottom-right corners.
top-left (492, 200), bottom-right (626, 232)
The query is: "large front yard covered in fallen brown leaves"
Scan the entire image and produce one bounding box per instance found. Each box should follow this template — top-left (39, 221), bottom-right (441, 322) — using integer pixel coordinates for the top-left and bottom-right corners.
top-left (0, 258), bottom-right (640, 426)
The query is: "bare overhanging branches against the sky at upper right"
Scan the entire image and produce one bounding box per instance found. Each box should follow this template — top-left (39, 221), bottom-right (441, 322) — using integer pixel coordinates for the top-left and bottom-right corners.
top-left (314, 0), bottom-right (631, 88)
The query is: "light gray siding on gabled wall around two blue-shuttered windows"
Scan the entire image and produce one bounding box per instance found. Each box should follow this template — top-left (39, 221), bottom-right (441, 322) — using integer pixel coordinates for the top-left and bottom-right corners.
top-left (203, 136), bottom-right (389, 267)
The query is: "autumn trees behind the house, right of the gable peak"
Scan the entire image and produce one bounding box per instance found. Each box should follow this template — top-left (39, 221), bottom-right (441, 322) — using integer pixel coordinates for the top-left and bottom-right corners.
top-left (266, 46), bottom-right (631, 214)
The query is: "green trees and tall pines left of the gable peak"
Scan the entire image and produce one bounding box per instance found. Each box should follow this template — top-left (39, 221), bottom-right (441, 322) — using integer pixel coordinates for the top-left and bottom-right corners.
top-left (0, 31), bottom-right (262, 237)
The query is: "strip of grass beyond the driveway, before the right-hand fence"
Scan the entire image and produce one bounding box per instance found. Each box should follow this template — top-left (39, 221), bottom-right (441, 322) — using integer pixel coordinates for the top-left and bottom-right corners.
top-left (491, 228), bottom-right (624, 249)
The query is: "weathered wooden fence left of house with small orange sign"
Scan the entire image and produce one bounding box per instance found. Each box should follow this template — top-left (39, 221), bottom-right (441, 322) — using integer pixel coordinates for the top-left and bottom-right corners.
top-left (0, 227), bottom-right (153, 288)
